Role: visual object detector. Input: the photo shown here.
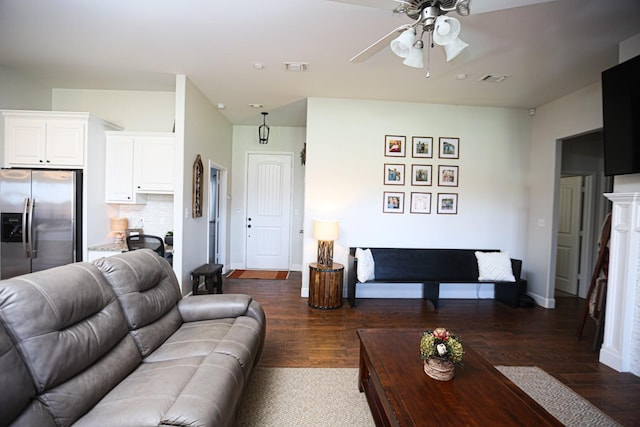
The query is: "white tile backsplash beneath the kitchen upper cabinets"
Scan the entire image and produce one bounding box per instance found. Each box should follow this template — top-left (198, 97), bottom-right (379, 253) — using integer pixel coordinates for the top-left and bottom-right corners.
top-left (119, 194), bottom-right (173, 237)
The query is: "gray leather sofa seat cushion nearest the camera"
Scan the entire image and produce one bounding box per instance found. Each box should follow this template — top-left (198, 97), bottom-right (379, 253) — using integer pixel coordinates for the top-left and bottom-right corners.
top-left (75, 353), bottom-right (244, 427)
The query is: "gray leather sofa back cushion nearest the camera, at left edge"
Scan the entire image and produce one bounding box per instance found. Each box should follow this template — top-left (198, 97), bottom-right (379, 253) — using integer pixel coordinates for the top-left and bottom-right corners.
top-left (0, 263), bottom-right (141, 425)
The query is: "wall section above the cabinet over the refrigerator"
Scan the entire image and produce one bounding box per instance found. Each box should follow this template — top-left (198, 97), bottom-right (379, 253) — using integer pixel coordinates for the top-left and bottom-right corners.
top-left (0, 66), bottom-right (51, 111)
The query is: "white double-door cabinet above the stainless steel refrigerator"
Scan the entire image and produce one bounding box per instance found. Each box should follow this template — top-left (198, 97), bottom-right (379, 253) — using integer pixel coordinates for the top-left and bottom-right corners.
top-left (2, 110), bottom-right (89, 168)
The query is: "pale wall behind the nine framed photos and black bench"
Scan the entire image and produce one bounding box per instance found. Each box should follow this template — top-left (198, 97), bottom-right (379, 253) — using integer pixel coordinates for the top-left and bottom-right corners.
top-left (301, 98), bottom-right (531, 298)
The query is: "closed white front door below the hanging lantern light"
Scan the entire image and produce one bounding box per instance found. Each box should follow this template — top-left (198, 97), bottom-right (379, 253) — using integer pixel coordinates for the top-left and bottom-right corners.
top-left (246, 154), bottom-right (293, 270)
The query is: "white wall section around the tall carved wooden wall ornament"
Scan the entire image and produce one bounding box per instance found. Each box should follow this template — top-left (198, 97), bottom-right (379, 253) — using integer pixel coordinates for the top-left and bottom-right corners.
top-left (173, 75), bottom-right (232, 294)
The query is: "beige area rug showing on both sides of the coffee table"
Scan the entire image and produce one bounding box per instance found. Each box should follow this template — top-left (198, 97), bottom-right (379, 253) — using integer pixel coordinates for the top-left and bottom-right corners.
top-left (235, 366), bottom-right (619, 427)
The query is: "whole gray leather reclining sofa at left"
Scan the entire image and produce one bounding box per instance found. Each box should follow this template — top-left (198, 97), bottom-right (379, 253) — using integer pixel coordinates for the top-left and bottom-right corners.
top-left (0, 249), bottom-right (266, 427)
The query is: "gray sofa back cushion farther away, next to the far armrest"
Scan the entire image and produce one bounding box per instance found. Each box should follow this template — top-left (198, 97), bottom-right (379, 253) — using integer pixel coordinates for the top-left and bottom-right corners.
top-left (93, 249), bottom-right (182, 357)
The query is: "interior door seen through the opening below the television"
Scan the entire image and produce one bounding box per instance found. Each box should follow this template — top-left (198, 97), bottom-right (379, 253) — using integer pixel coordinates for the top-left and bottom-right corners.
top-left (556, 176), bottom-right (582, 295)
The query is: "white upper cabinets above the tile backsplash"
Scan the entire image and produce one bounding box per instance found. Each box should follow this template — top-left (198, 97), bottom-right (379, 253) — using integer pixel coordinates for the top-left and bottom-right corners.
top-left (105, 132), bottom-right (176, 204)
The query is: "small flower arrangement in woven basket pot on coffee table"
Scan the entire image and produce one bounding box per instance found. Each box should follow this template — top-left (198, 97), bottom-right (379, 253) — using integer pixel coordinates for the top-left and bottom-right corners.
top-left (420, 328), bottom-right (464, 381)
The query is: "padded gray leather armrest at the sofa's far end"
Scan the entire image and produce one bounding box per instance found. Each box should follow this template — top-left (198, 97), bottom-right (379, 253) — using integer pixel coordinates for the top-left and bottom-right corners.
top-left (178, 294), bottom-right (264, 324)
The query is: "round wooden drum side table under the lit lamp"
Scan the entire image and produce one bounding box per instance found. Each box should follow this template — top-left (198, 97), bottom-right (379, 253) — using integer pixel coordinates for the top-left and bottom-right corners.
top-left (309, 262), bottom-right (344, 310)
